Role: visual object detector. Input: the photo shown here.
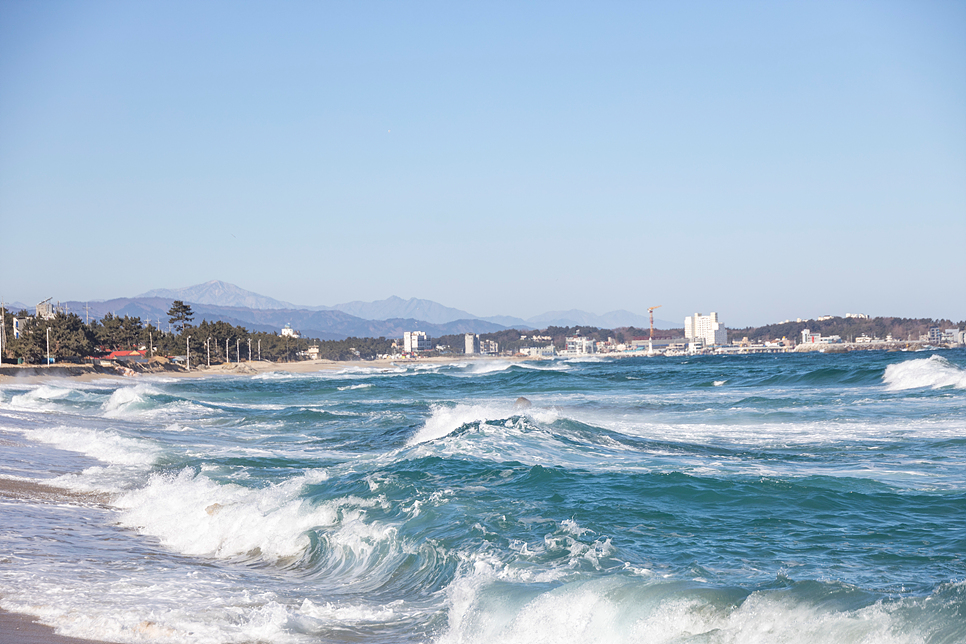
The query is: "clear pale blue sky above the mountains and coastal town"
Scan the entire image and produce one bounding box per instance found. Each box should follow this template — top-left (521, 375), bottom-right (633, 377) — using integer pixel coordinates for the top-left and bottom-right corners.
top-left (0, 0), bottom-right (966, 326)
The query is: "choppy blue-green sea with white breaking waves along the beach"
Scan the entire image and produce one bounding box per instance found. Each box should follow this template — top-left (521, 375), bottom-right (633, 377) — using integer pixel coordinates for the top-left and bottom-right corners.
top-left (0, 350), bottom-right (966, 644)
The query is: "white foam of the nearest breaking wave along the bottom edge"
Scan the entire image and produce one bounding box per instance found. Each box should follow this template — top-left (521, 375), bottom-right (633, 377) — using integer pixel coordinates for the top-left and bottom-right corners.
top-left (437, 567), bottom-right (923, 644)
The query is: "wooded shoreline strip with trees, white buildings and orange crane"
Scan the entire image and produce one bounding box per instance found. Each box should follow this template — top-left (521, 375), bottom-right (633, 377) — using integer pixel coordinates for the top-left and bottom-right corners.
top-left (0, 298), bottom-right (966, 369)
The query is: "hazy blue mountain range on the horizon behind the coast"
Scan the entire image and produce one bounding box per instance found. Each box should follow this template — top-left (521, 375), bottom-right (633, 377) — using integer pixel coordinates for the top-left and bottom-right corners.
top-left (8, 280), bottom-right (680, 340)
